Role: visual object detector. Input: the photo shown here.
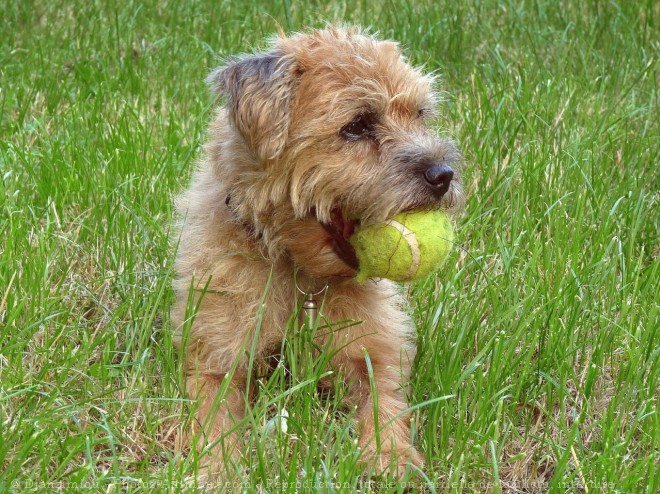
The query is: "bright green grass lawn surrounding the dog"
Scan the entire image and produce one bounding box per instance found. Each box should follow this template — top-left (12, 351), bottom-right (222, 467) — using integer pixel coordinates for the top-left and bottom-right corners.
top-left (0, 0), bottom-right (660, 493)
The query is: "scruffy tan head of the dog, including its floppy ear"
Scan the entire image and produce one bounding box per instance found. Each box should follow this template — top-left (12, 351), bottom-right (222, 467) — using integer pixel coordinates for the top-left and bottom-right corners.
top-left (209, 28), bottom-right (462, 276)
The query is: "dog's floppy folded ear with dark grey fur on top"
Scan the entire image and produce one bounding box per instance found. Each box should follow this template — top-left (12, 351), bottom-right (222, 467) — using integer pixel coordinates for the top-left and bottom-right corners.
top-left (207, 50), bottom-right (300, 160)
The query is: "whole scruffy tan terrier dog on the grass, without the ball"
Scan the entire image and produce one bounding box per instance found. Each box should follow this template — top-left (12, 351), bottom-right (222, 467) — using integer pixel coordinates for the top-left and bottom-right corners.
top-left (172, 27), bottom-right (462, 474)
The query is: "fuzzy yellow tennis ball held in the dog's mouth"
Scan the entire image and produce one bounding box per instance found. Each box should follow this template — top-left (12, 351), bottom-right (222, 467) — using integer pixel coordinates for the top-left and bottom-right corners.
top-left (350, 211), bottom-right (454, 283)
